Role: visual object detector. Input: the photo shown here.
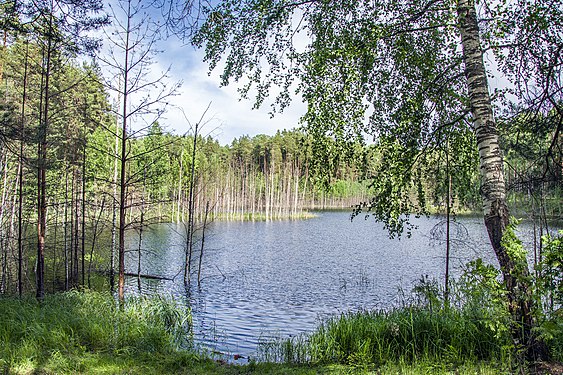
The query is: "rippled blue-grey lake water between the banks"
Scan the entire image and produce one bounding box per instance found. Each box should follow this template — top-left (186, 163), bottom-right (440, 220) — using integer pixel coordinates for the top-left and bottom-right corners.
top-left (122, 212), bottom-right (556, 357)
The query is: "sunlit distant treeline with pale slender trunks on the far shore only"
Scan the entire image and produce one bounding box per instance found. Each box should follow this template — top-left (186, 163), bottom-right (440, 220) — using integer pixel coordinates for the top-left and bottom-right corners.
top-left (89, 123), bottom-right (374, 222)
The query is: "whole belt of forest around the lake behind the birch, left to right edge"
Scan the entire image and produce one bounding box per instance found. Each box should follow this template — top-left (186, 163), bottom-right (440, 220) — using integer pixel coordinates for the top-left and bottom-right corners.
top-left (0, 34), bottom-right (562, 294)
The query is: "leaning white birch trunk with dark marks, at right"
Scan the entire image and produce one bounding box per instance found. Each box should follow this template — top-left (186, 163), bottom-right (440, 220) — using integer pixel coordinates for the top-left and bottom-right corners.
top-left (457, 0), bottom-right (546, 359)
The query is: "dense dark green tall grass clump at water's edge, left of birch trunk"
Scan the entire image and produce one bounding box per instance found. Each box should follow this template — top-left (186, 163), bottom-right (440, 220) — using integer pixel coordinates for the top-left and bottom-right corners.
top-left (264, 307), bottom-right (511, 369)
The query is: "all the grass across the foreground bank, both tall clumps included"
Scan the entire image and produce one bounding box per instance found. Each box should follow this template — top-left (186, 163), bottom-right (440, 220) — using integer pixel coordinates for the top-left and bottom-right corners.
top-left (0, 291), bottom-right (560, 375)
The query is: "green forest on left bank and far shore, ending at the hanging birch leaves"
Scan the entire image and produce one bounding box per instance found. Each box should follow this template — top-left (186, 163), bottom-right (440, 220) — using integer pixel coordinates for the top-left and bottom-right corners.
top-left (0, 0), bottom-right (374, 300)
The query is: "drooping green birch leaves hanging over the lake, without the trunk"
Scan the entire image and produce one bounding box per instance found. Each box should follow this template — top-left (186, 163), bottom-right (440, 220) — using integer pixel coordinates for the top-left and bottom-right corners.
top-left (192, 0), bottom-right (486, 235)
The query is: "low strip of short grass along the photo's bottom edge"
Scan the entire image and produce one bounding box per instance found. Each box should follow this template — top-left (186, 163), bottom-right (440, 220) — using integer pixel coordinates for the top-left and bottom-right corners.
top-left (0, 352), bottom-right (509, 375)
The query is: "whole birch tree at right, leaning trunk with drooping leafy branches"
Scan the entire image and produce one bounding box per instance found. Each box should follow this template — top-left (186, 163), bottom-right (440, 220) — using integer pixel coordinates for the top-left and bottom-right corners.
top-left (186, 0), bottom-right (563, 358)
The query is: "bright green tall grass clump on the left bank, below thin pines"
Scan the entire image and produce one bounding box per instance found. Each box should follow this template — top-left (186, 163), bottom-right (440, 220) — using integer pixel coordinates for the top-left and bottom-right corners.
top-left (0, 291), bottom-right (191, 372)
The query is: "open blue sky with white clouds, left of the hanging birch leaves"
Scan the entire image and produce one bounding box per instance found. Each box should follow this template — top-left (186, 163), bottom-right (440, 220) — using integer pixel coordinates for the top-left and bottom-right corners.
top-left (98, 0), bottom-right (306, 145)
